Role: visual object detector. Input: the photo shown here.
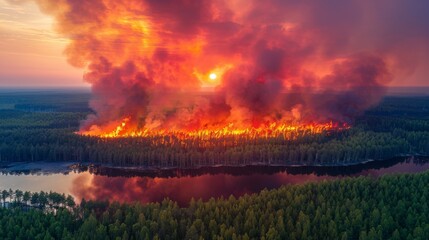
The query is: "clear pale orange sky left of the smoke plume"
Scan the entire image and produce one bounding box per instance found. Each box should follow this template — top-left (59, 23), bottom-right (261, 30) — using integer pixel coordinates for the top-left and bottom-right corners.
top-left (0, 0), bottom-right (88, 87)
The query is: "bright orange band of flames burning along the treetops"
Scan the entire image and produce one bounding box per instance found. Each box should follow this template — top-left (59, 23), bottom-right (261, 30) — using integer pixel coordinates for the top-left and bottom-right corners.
top-left (80, 117), bottom-right (350, 140)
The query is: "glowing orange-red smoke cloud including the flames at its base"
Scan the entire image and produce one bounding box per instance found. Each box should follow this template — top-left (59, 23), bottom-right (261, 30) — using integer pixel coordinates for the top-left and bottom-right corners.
top-left (33, 0), bottom-right (389, 140)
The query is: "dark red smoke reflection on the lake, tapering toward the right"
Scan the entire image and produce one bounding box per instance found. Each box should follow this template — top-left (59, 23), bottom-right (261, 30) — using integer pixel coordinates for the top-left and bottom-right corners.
top-left (71, 173), bottom-right (332, 205)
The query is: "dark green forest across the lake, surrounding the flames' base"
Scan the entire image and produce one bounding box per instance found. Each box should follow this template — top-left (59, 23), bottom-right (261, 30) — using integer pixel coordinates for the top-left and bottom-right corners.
top-left (0, 92), bottom-right (429, 168)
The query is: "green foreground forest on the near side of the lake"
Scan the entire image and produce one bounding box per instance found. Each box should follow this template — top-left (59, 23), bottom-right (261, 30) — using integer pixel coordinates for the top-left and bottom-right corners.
top-left (0, 172), bottom-right (429, 240)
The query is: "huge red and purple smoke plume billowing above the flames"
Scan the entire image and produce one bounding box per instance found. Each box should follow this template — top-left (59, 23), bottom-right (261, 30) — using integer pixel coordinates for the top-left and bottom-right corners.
top-left (25, 0), bottom-right (429, 131)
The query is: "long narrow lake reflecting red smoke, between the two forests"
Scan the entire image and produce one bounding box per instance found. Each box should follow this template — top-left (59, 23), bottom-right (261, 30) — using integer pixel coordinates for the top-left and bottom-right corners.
top-left (0, 158), bottom-right (429, 205)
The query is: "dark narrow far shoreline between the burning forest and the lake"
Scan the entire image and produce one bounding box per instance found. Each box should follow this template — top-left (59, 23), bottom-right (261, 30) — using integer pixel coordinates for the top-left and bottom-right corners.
top-left (0, 154), bottom-right (429, 177)
